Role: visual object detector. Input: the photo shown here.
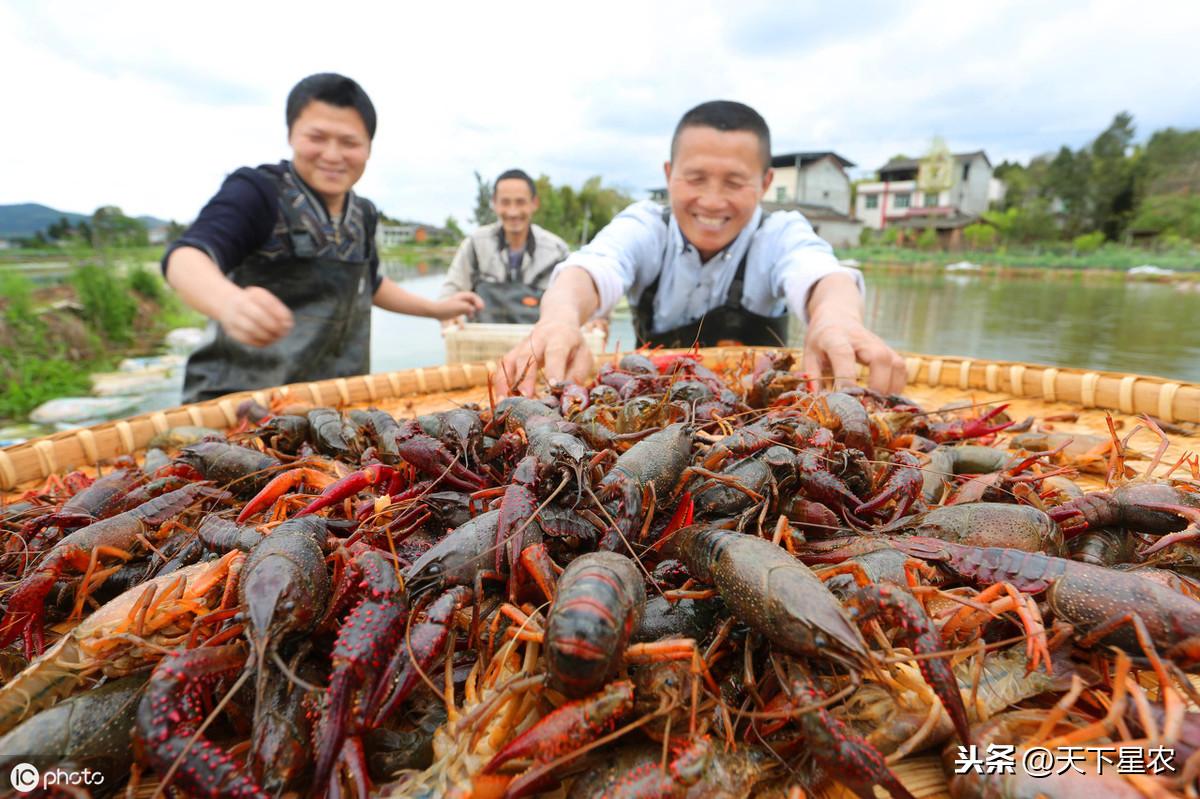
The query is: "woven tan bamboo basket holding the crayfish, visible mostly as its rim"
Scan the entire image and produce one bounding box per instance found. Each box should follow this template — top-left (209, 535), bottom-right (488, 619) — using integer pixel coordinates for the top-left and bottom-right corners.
top-left (0, 347), bottom-right (1200, 799)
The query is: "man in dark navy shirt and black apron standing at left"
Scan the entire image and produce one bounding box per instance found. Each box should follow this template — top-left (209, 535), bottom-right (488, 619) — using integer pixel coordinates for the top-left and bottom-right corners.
top-left (163, 73), bottom-right (482, 402)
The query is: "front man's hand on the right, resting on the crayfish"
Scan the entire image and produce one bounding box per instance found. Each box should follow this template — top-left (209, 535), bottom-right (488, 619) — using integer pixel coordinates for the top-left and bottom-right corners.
top-left (804, 314), bottom-right (908, 394)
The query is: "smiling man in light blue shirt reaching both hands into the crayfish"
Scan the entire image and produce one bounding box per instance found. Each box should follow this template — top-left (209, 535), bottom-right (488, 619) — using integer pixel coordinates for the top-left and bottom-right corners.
top-left (498, 100), bottom-right (906, 394)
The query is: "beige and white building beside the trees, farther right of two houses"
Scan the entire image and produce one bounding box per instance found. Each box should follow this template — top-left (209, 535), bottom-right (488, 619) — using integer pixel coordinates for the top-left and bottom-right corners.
top-left (854, 148), bottom-right (1004, 246)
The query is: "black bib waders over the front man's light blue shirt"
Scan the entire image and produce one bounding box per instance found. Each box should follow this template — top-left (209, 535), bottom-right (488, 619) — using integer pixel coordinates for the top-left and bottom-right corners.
top-left (634, 209), bottom-right (787, 348)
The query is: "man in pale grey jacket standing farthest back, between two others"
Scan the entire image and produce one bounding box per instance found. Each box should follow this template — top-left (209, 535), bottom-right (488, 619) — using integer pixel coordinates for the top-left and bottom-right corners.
top-left (442, 169), bottom-right (570, 324)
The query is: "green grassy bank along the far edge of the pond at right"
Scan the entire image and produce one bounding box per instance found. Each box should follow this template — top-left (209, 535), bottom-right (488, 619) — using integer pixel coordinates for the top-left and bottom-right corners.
top-left (838, 244), bottom-right (1200, 274)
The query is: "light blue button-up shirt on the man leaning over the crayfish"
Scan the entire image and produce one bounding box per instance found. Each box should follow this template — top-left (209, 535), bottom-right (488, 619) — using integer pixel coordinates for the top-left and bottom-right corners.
top-left (551, 200), bottom-right (864, 332)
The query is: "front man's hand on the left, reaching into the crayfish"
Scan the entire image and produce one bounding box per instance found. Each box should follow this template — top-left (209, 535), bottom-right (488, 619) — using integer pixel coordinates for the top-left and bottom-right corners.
top-left (496, 319), bottom-right (592, 397)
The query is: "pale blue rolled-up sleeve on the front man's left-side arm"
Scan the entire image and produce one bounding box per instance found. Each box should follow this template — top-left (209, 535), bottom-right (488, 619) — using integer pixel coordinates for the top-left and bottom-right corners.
top-left (550, 203), bottom-right (666, 319)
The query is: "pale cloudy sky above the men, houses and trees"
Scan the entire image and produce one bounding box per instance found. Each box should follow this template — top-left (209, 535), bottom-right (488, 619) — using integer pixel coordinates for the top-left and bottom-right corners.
top-left (0, 0), bottom-right (1200, 227)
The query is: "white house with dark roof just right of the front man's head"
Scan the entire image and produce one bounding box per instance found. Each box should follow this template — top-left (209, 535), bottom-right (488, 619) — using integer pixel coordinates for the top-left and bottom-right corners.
top-left (650, 150), bottom-right (863, 247)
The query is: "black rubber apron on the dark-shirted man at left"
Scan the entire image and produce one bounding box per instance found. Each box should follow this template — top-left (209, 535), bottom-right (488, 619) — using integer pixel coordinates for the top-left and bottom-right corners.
top-left (184, 197), bottom-right (374, 403)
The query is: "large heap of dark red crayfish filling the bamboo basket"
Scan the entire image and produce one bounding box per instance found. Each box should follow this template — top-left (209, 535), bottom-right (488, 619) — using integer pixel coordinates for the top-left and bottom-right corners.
top-left (0, 352), bottom-right (1200, 799)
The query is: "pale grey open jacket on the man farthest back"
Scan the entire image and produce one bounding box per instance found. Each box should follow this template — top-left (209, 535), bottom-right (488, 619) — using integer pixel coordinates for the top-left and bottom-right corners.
top-left (440, 222), bottom-right (571, 299)
